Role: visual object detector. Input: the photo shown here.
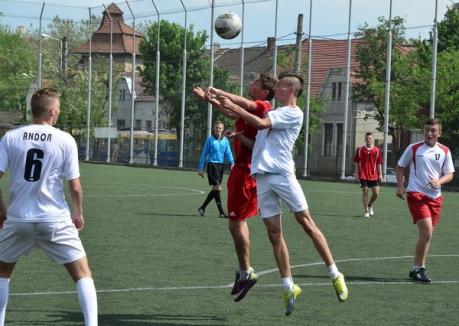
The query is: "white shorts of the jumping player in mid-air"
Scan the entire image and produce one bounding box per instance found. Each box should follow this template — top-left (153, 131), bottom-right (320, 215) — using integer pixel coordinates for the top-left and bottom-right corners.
top-left (255, 173), bottom-right (308, 218)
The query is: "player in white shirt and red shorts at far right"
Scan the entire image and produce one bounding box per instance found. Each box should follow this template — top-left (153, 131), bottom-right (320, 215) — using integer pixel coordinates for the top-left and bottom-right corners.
top-left (396, 119), bottom-right (454, 283)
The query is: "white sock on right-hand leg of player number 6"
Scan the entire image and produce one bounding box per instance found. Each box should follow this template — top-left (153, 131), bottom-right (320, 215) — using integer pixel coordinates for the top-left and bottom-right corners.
top-left (76, 277), bottom-right (97, 326)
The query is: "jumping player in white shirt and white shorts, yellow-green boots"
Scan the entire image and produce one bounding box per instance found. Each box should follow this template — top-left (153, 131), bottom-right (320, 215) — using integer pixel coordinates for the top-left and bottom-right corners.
top-left (221, 74), bottom-right (348, 315)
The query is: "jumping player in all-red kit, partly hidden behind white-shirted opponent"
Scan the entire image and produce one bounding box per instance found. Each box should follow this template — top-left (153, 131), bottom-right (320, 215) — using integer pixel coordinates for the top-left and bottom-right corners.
top-left (193, 74), bottom-right (276, 302)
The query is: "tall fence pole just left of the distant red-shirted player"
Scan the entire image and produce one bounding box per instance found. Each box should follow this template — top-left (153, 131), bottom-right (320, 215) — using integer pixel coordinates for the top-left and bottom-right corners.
top-left (340, 0), bottom-right (352, 179)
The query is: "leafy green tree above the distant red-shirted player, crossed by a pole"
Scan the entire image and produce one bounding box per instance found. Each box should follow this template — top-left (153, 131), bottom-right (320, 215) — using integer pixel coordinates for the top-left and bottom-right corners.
top-left (353, 17), bottom-right (429, 158)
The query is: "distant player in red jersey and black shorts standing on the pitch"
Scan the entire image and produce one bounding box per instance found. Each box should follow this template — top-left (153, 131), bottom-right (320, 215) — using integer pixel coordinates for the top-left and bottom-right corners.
top-left (354, 132), bottom-right (382, 218)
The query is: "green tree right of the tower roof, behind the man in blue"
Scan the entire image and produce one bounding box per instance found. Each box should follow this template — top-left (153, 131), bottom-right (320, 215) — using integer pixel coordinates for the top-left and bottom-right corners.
top-left (139, 20), bottom-right (236, 141)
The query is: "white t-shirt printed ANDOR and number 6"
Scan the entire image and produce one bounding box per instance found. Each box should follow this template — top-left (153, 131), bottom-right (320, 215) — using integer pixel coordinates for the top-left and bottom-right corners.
top-left (0, 124), bottom-right (80, 222)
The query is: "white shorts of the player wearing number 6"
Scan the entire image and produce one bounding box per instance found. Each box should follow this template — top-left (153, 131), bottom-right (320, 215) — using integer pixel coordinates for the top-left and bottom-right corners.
top-left (0, 219), bottom-right (86, 265)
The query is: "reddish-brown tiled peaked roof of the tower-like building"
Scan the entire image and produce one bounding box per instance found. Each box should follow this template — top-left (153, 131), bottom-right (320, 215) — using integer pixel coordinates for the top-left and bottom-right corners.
top-left (72, 3), bottom-right (142, 55)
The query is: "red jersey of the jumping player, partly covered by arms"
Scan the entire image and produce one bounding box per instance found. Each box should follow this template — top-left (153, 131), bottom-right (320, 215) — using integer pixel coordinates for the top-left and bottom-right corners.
top-left (233, 100), bottom-right (271, 164)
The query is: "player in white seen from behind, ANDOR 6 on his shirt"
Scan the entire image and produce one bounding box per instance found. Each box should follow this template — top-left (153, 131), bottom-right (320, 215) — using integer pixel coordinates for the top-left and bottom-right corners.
top-left (0, 88), bottom-right (98, 326)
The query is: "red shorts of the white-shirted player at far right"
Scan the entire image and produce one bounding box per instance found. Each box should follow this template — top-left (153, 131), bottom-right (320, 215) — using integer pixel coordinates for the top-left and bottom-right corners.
top-left (406, 192), bottom-right (443, 226)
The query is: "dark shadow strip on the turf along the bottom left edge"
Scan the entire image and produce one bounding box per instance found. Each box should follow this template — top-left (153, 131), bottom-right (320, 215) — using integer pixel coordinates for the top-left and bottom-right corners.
top-left (6, 310), bottom-right (227, 326)
